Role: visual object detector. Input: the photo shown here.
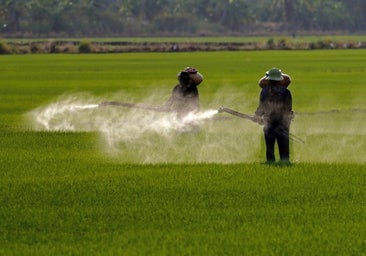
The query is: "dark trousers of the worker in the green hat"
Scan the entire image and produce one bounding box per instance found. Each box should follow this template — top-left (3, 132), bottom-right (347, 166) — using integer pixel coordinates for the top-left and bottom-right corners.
top-left (264, 123), bottom-right (290, 163)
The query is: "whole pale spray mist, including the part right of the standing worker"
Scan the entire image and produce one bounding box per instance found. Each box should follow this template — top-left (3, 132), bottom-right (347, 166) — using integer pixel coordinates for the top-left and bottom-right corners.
top-left (27, 94), bottom-right (366, 163)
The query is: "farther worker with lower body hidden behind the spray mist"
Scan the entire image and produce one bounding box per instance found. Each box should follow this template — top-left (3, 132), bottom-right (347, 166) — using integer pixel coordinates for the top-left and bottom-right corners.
top-left (163, 67), bottom-right (203, 118)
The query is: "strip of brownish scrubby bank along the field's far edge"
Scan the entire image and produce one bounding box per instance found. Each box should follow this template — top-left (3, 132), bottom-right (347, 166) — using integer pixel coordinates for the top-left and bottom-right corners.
top-left (0, 36), bottom-right (366, 54)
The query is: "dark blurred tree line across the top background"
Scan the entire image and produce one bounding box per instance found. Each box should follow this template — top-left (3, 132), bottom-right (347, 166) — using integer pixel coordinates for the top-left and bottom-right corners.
top-left (0, 0), bottom-right (366, 37)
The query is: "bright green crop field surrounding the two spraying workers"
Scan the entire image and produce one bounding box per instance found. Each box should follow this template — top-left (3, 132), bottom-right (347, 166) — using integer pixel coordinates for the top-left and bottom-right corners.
top-left (0, 50), bottom-right (366, 255)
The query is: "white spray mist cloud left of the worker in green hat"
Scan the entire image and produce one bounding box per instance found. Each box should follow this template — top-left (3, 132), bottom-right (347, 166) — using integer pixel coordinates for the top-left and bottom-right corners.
top-left (27, 94), bottom-right (260, 163)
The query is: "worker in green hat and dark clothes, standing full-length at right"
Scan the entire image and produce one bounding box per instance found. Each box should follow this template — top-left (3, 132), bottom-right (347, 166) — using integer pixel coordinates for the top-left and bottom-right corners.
top-left (255, 68), bottom-right (293, 164)
